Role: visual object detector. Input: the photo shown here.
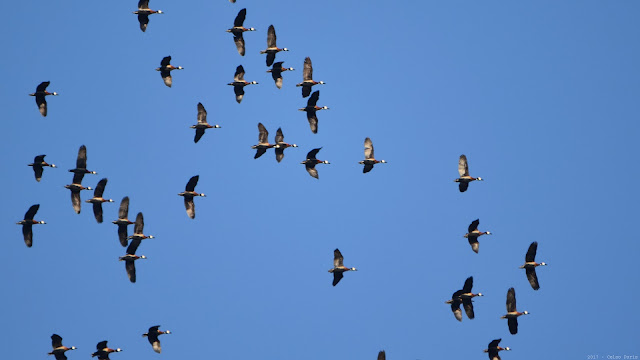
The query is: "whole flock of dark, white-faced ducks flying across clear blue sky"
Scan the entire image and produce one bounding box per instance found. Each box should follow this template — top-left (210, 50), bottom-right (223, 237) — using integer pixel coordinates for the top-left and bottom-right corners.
top-left (17, 0), bottom-right (546, 360)
